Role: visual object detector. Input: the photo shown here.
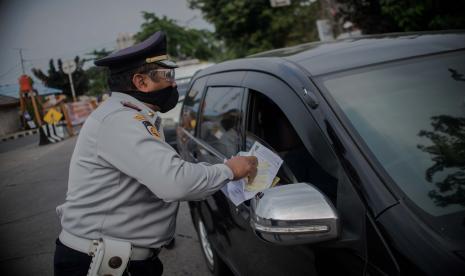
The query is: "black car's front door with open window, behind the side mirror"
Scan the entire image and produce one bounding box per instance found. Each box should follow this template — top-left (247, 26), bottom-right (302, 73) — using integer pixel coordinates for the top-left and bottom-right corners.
top-left (223, 72), bottom-right (376, 275)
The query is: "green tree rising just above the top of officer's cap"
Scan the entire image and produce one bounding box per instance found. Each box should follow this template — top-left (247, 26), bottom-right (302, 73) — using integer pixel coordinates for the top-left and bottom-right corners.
top-left (134, 12), bottom-right (219, 60)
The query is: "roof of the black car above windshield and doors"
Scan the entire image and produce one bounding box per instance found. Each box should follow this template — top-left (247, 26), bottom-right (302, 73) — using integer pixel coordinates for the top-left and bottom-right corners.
top-left (201, 31), bottom-right (465, 76)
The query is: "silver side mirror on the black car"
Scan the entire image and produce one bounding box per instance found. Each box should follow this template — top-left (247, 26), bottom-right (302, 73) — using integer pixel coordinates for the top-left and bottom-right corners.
top-left (250, 183), bottom-right (339, 245)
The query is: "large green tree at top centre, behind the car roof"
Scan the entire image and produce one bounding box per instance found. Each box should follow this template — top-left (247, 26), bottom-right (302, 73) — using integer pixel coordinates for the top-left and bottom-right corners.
top-left (188, 0), bottom-right (319, 57)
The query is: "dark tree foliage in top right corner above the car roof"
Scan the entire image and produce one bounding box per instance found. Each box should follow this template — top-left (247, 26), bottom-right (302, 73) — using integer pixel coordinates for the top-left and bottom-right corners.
top-left (336, 0), bottom-right (465, 34)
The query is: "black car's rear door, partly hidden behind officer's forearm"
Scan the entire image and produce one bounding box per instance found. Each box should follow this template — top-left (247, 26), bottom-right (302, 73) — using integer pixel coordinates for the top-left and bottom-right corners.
top-left (191, 72), bottom-right (250, 270)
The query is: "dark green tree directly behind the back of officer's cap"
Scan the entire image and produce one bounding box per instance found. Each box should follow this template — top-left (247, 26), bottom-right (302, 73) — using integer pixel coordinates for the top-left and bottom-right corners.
top-left (86, 49), bottom-right (110, 96)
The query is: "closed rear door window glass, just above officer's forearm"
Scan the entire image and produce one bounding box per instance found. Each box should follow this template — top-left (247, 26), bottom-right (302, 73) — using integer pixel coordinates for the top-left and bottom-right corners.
top-left (200, 87), bottom-right (244, 158)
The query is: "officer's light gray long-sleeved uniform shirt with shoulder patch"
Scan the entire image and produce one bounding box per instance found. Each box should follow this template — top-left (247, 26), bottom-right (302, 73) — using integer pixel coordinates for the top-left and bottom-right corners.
top-left (57, 92), bottom-right (233, 248)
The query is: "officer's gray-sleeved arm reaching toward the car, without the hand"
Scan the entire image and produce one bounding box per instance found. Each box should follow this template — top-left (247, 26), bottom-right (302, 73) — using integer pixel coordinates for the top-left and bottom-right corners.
top-left (97, 110), bottom-right (234, 201)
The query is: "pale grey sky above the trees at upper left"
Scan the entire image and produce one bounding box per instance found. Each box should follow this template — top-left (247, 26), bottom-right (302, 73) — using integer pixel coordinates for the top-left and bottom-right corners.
top-left (0, 0), bottom-right (214, 90)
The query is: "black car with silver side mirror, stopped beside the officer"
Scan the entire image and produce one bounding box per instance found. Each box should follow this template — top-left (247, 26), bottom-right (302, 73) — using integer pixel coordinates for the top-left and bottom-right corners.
top-left (177, 32), bottom-right (465, 275)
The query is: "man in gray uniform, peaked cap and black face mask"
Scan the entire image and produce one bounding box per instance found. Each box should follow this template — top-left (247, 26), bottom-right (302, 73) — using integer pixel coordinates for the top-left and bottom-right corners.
top-left (54, 32), bottom-right (257, 276)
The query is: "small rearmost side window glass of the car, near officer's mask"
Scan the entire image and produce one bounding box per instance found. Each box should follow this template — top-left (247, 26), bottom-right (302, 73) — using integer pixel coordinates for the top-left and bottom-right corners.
top-left (180, 78), bottom-right (206, 134)
